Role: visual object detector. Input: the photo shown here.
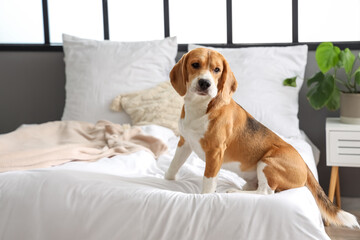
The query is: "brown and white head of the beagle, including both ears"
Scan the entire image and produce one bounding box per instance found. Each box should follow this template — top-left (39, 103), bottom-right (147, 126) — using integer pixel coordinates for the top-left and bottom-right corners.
top-left (170, 48), bottom-right (237, 102)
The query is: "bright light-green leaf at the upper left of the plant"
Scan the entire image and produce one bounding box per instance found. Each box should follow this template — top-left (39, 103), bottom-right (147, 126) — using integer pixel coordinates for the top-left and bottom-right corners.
top-left (315, 42), bottom-right (340, 73)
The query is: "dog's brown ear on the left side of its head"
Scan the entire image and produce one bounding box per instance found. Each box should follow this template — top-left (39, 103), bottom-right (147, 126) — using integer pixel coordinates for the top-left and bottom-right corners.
top-left (170, 54), bottom-right (188, 96)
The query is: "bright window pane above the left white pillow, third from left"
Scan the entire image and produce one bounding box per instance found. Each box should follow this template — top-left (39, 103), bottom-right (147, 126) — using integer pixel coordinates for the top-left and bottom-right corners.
top-left (108, 0), bottom-right (164, 41)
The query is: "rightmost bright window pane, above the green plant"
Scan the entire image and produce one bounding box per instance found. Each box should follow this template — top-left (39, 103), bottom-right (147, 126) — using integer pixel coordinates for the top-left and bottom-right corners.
top-left (299, 0), bottom-right (360, 42)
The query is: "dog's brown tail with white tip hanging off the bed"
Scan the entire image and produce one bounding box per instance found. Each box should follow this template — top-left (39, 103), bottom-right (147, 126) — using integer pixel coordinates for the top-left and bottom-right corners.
top-left (306, 168), bottom-right (360, 228)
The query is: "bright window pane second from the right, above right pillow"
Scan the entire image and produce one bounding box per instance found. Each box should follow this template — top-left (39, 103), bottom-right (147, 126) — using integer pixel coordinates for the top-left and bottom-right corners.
top-left (232, 0), bottom-right (292, 43)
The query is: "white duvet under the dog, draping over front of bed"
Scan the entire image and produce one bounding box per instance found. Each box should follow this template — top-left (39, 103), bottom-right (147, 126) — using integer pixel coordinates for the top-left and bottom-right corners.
top-left (0, 125), bottom-right (329, 240)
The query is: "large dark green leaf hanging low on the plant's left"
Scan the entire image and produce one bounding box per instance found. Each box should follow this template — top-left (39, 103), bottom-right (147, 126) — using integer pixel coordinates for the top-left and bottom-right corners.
top-left (306, 73), bottom-right (336, 110)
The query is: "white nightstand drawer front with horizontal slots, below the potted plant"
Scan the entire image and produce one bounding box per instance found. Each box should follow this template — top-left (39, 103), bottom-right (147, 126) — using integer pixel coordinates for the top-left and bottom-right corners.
top-left (327, 131), bottom-right (360, 166)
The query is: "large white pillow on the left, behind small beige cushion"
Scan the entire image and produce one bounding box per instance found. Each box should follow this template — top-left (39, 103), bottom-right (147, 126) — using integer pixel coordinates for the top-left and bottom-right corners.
top-left (62, 34), bottom-right (177, 123)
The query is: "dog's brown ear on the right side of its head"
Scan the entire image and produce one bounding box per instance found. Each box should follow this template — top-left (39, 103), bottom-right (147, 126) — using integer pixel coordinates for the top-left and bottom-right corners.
top-left (218, 58), bottom-right (237, 102)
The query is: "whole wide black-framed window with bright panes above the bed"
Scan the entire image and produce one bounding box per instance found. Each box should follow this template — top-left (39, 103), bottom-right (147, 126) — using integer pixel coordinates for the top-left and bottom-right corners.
top-left (0, 0), bottom-right (360, 51)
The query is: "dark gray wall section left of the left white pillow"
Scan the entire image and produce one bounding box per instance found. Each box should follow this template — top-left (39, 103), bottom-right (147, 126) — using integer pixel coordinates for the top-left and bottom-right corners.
top-left (0, 52), bottom-right (65, 133)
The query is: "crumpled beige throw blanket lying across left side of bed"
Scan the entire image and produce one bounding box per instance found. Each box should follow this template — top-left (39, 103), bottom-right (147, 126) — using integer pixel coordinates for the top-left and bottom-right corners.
top-left (0, 121), bottom-right (167, 172)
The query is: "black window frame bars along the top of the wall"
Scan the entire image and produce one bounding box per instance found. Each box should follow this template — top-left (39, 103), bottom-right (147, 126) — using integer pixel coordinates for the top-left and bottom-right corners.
top-left (0, 0), bottom-right (360, 52)
